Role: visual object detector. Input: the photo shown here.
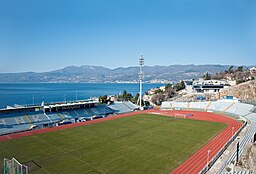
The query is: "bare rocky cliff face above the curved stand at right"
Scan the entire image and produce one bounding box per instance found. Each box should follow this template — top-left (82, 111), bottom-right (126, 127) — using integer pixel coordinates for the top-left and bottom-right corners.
top-left (220, 80), bottom-right (256, 103)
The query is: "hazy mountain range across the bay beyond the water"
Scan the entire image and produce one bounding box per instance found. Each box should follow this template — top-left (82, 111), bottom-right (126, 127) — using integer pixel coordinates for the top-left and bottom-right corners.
top-left (0, 64), bottom-right (251, 83)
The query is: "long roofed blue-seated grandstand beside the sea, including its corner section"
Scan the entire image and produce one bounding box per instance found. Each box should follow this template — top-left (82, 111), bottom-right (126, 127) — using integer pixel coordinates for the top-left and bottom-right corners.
top-left (0, 101), bottom-right (135, 135)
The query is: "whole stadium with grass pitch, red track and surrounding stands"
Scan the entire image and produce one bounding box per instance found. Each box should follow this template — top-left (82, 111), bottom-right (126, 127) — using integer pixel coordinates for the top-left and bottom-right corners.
top-left (0, 96), bottom-right (256, 173)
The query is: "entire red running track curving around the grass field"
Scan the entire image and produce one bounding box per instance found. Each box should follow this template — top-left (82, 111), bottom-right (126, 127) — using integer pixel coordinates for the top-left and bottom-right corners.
top-left (0, 110), bottom-right (242, 174)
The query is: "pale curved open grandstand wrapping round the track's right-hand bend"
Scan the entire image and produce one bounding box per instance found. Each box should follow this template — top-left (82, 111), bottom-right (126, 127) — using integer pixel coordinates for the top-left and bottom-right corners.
top-left (161, 100), bottom-right (256, 173)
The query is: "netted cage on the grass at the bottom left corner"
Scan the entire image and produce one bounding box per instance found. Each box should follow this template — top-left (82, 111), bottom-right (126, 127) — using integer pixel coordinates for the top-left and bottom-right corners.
top-left (4, 158), bottom-right (28, 174)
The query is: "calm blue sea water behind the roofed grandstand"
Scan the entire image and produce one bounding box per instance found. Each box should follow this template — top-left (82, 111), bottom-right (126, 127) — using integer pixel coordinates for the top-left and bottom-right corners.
top-left (0, 83), bottom-right (164, 108)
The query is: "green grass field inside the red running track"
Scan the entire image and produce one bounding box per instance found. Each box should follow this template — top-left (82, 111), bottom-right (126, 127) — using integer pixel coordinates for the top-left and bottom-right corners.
top-left (0, 114), bottom-right (226, 174)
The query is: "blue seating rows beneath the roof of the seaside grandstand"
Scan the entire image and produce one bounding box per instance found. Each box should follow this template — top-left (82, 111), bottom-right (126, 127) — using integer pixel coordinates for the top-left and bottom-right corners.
top-left (0, 105), bottom-right (117, 135)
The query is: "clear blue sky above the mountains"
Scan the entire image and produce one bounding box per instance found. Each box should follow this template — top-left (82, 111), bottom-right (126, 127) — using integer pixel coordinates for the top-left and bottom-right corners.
top-left (0, 0), bottom-right (256, 72)
